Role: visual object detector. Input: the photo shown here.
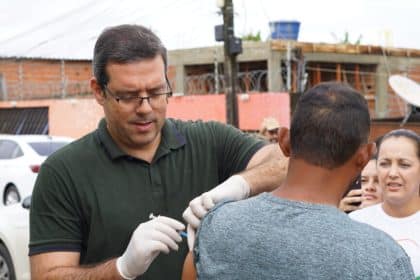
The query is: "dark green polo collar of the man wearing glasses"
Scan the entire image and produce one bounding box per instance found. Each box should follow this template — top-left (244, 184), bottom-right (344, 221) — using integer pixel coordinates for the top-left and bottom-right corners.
top-left (96, 118), bottom-right (186, 159)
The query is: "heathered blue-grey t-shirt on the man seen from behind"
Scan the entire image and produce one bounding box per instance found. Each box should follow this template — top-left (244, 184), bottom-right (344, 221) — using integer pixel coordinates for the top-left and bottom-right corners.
top-left (194, 193), bottom-right (414, 280)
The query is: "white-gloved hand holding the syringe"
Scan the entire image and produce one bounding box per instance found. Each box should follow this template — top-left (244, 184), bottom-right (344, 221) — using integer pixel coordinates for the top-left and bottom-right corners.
top-left (117, 216), bottom-right (185, 279)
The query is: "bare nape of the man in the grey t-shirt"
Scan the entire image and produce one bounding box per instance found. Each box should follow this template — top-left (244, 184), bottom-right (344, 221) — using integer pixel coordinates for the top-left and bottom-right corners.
top-left (273, 159), bottom-right (351, 206)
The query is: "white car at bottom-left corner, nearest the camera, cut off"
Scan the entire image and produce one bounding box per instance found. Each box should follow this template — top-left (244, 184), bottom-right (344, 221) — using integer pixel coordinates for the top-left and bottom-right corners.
top-left (0, 197), bottom-right (31, 280)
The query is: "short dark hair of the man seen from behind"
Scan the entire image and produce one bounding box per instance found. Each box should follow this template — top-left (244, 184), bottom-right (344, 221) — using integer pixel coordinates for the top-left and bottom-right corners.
top-left (290, 82), bottom-right (370, 169)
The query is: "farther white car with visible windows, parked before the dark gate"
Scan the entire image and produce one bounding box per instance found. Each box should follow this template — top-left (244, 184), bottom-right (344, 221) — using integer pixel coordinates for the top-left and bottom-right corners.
top-left (0, 134), bottom-right (73, 207)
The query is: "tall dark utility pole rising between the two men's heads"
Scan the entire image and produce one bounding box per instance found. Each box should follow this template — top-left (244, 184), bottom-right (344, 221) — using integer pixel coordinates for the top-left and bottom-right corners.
top-left (222, 0), bottom-right (239, 127)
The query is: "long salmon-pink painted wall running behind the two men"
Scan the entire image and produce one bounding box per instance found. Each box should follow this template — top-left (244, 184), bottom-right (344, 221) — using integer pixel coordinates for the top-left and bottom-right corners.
top-left (0, 93), bottom-right (290, 138)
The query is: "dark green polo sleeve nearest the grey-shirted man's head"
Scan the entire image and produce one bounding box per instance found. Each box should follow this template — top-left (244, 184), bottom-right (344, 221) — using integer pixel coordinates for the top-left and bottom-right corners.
top-left (210, 122), bottom-right (267, 180)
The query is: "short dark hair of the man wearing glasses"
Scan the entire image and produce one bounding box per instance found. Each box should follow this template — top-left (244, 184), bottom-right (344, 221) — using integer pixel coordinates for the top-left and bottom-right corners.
top-left (92, 24), bottom-right (167, 88)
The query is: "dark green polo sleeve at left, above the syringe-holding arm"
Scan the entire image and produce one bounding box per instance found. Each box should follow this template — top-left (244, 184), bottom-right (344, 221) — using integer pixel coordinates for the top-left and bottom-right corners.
top-left (29, 163), bottom-right (82, 256)
